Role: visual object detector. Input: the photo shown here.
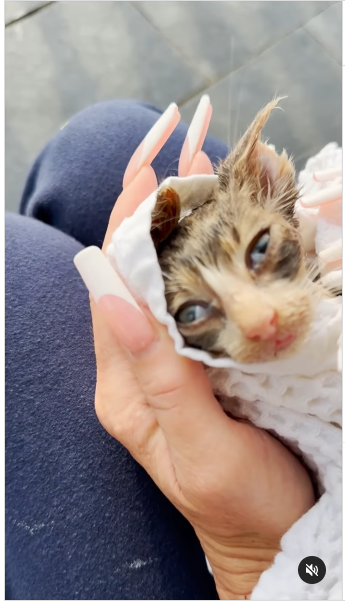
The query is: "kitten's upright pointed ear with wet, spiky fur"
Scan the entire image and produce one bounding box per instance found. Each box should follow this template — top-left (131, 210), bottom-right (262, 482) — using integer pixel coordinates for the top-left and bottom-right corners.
top-left (218, 98), bottom-right (298, 218)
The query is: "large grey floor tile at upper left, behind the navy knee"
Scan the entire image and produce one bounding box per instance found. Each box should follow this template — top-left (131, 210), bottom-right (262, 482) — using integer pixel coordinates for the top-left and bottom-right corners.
top-left (6, 2), bottom-right (206, 207)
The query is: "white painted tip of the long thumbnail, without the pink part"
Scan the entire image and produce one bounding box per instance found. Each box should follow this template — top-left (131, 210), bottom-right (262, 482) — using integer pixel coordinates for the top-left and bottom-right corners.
top-left (74, 246), bottom-right (141, 311)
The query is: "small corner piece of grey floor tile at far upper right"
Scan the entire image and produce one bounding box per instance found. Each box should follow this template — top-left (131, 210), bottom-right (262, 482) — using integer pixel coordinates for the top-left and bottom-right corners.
top-left (305, 2), bottom-right (342, 64)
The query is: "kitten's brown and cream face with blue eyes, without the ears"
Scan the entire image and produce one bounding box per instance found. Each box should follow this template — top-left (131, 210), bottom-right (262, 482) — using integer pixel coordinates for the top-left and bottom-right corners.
top-left (160, 201), bottom-right (312, 363)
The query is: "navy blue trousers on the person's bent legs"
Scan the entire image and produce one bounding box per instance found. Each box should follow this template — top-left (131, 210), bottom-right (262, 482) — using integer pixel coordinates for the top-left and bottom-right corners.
top-left (6, 101), bottom-right (227, 599)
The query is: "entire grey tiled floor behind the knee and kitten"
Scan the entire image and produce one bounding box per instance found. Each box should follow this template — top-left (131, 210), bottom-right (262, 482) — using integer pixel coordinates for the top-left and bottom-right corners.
top-left (5, 1), bottom-right (342, 211)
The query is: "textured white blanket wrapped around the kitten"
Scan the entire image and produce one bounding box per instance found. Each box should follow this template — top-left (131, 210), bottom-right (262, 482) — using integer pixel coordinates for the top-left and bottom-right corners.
top-left (108, 144), bottom-right (342, 601)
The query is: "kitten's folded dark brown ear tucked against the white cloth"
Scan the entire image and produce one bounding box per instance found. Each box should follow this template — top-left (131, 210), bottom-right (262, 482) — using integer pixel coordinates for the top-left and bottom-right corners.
top-left (151, 187), bottom-right (181, 248)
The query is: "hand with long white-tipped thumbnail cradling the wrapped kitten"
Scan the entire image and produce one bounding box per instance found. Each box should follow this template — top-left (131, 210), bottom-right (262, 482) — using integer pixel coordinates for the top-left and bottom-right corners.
top-left (75, 167), bottom-right (314, 599)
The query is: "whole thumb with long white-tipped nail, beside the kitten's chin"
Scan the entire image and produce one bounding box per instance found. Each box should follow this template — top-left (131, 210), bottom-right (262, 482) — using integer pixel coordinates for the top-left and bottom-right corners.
top-left (76, 247), bottom-right (239, 461)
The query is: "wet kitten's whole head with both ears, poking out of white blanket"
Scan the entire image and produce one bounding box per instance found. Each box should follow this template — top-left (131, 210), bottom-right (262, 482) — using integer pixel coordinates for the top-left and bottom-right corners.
top-left (151, 100), bottom-right (322, 363)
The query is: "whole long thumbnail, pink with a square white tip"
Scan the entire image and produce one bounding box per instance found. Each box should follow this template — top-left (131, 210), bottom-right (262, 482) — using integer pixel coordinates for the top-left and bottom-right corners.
top-left (74, 246), bottom-right (156, 353)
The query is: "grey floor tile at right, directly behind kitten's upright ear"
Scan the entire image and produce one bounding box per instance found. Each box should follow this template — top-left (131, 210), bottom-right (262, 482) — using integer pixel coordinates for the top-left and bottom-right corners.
top-left (181, 29), bottom-right (341, 175)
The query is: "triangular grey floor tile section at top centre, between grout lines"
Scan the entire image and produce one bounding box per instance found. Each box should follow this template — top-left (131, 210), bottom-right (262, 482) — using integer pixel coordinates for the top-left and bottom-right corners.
top-left (133, 1), bottom-right (330, 81)
